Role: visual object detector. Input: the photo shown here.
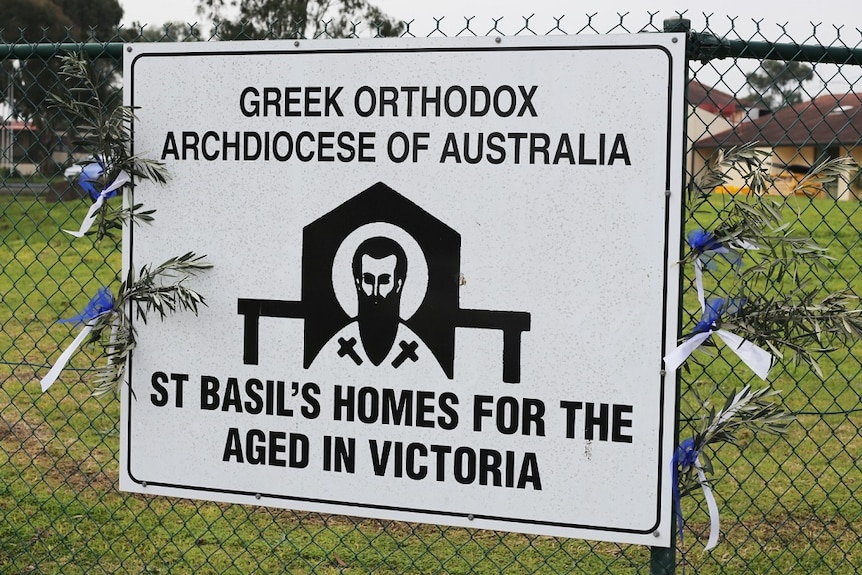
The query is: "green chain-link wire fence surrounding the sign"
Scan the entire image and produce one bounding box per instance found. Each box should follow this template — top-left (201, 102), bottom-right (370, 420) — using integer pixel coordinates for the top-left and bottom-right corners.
top-left (0, 15), bottom-right (862, 575)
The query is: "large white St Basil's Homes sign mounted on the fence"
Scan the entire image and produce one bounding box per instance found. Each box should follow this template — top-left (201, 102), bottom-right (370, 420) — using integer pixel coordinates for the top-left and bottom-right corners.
top-left (120, 34), bottom-right (685, 545)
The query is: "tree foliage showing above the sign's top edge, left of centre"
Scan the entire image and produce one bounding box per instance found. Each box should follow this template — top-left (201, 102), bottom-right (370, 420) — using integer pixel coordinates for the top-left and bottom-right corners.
top-left (198, 0), bottom-right (405, 40)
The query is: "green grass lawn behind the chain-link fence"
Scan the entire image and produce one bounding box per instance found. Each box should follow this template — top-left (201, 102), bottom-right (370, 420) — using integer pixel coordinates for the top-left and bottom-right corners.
top-left (0, 197), bottom-right (862, 575)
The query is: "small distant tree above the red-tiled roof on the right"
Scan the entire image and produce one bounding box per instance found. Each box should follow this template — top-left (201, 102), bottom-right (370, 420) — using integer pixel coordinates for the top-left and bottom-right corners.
top-left (745, 60), bottom-right (814, 111)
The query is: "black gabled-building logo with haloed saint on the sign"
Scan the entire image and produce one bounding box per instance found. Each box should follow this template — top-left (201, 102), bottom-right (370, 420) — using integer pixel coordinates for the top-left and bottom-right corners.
top-left (237, 183), bottom-right (530, 383)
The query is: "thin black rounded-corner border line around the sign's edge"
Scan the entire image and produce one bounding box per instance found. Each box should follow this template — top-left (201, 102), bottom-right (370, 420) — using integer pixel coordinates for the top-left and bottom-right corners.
top-left (126, 42), bottom-right (685, 535)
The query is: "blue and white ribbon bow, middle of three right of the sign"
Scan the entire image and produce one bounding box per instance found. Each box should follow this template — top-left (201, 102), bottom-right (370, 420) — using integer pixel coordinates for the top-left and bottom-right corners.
top-left (664, 298), bottom-right (772, 379)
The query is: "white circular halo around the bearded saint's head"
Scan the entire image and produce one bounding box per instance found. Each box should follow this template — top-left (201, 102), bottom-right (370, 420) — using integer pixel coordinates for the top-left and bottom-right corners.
top-left (332, 222), bottom-right (428, 320)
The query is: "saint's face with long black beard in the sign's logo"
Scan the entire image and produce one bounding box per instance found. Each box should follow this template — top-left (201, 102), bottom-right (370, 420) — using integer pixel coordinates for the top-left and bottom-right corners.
top-left (354, 254), bottom-right (404, 365)
